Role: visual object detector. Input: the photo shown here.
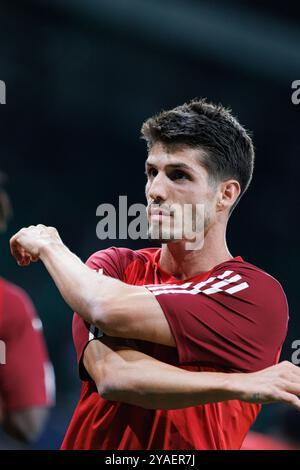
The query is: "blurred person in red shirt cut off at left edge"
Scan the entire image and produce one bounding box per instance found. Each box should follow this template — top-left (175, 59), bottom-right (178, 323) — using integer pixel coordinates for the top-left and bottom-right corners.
top-left (0, 173), bottom-right (55, 443)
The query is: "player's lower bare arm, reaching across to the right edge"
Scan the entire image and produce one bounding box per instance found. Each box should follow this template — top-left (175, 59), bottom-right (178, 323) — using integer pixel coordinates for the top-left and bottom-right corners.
top-left (84, 338), bottom-right (300, 411)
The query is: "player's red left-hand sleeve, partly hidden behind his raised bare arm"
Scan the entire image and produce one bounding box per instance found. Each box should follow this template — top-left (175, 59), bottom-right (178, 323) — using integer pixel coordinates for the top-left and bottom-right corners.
top-left (72, 247), bottom-right (126, 380)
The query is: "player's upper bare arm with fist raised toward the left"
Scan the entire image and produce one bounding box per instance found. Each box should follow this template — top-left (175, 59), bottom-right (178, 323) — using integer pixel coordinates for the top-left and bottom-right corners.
top-left (10, 225), bottom-right (175, 346)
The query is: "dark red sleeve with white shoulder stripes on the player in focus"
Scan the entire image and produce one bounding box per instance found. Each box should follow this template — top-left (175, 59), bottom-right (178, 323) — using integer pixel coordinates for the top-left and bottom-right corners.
top-left (146, 268), bottom-right (288, 372)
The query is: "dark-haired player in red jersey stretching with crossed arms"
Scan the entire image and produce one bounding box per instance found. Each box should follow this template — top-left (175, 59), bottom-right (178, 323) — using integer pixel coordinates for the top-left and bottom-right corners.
top-left (10, 100), bottom-right (300, 450)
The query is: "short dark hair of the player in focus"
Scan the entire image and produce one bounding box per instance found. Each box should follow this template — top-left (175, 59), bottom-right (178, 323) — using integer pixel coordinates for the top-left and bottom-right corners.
top-left (141, 99), bottom-right (254, 212)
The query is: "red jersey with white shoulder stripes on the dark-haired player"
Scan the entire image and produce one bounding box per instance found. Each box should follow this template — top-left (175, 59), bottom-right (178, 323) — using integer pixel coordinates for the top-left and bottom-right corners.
top-left (62, 248), bottom-right (288, 450)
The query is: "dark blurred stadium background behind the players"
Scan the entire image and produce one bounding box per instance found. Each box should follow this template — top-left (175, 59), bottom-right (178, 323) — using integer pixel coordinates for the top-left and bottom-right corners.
top-left (0, 0), bottom-right (300, 449)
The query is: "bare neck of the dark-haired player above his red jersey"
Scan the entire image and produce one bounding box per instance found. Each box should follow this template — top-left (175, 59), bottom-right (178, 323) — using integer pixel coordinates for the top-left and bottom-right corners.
top-left (160, 220), bottom-right (232, 280)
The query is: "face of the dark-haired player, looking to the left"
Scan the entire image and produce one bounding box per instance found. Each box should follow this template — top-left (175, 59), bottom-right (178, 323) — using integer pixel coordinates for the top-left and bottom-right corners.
top-left (146, 143), bottom-right (216, 243)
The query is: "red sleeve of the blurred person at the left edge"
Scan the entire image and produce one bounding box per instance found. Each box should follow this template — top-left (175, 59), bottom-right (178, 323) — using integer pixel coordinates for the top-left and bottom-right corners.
top-left (0, 284), bottom-right (55, 412)
